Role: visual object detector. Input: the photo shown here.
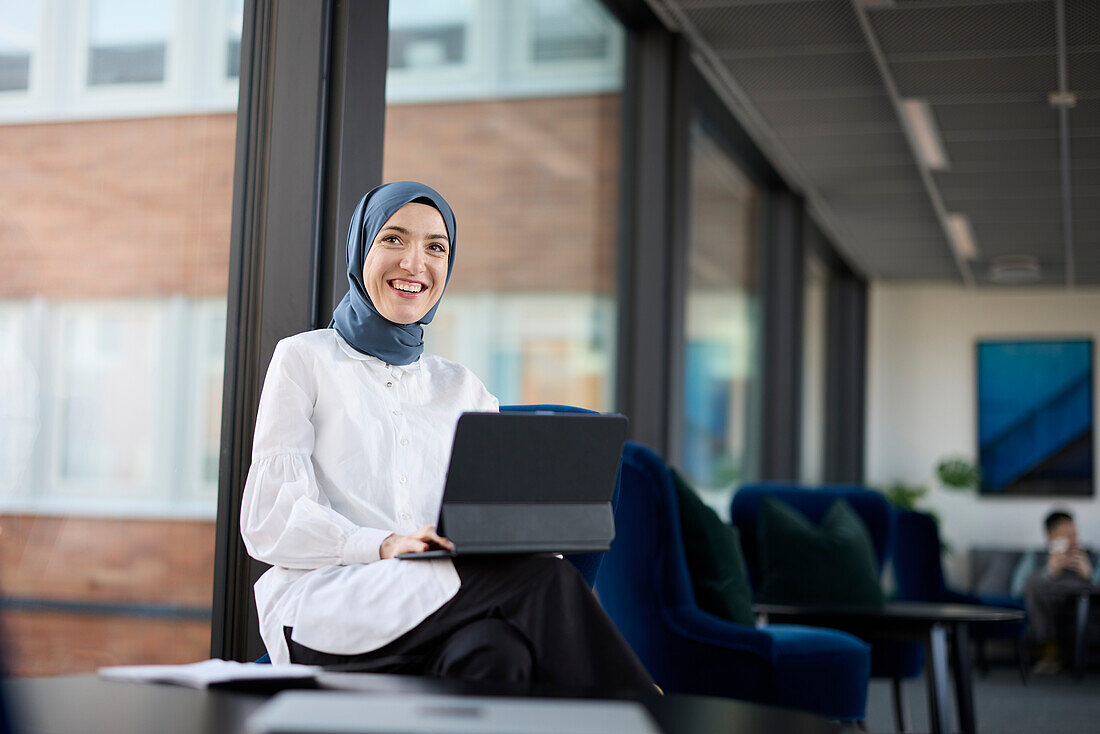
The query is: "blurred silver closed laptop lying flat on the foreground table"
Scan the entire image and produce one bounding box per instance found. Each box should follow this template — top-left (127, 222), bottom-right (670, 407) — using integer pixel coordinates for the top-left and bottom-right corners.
top-left (245, 691), bottom-right (660, 734)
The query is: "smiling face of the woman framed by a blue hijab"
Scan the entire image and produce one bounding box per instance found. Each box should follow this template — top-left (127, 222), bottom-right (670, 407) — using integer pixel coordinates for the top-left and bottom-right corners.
top-left (363, 204), bottom-right (451, 324)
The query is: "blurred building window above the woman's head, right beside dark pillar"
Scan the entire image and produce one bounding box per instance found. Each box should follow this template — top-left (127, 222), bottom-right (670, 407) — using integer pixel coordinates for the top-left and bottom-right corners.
top-left (388, 0), bottom-right (475, 69)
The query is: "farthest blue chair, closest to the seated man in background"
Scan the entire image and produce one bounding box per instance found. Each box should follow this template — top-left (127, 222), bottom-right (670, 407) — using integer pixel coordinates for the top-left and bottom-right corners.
top-left (893, 511), bottom-right (1027, 683)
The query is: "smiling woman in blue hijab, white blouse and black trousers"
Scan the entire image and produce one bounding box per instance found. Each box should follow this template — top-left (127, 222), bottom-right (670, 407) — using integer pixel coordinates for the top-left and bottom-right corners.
top-left (241, 182), bottom-right (652, 688)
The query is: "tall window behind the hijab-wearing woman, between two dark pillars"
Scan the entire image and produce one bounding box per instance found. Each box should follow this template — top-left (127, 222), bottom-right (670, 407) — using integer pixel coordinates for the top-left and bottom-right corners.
top-left (384, 0), bottom-right (623, 409)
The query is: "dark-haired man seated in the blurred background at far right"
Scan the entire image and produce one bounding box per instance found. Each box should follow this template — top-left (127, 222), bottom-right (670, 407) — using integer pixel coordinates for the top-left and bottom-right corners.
top-left (1012, 510), bottom-right (1100, 673)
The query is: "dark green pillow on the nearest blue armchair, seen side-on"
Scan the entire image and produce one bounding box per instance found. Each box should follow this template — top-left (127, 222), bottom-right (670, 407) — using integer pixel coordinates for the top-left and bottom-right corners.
top-left (672, 469), bottom-right (755, 626)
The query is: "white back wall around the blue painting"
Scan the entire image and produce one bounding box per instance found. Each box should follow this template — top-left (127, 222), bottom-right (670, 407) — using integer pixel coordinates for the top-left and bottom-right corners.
top-left (865, 283), bottom-right (1100, 587)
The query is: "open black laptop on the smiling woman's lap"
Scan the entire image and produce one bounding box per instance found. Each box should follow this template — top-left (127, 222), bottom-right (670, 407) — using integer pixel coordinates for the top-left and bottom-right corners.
top-left (398, 413), bottom-right (627, 560)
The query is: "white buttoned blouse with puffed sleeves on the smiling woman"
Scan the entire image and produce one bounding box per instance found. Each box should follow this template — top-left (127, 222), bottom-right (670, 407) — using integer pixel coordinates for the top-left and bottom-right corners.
top-left (241, 329), bottom-right (498, 664)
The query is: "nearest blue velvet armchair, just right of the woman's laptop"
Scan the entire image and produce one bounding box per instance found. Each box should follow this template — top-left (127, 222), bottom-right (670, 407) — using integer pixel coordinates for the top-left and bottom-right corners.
top-left (596, 441), bottom-right (869, 721)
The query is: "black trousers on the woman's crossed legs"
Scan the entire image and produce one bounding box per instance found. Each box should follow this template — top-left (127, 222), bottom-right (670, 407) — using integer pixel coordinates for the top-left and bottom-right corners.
top-left (285, 556), bottom-right (653, 690)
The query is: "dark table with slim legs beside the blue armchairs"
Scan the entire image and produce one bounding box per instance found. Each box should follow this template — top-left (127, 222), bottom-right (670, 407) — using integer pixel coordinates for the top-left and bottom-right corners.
top-left (752, 602), bottom-right (1024, 734)
